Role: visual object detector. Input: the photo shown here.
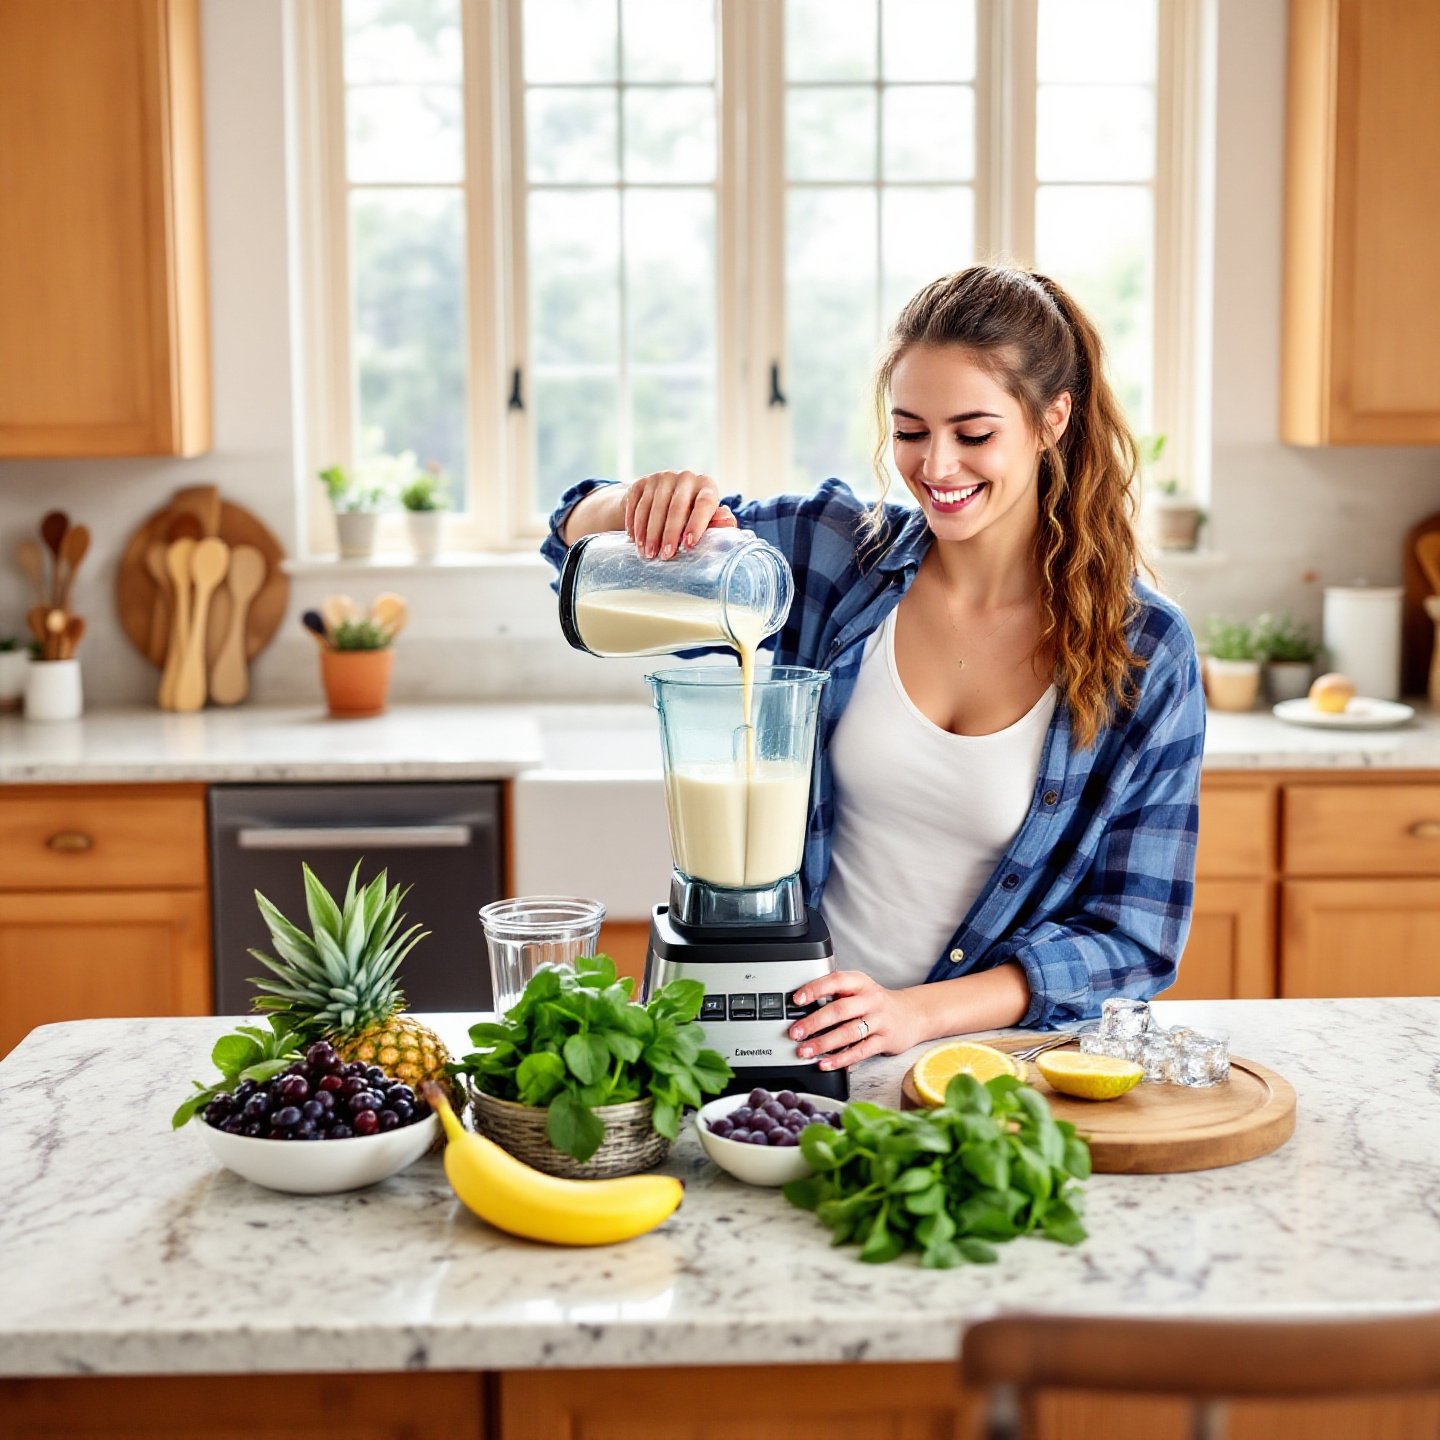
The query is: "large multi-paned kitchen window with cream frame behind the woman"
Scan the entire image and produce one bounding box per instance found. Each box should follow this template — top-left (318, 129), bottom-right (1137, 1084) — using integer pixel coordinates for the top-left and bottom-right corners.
top-left (298, 0), bottom-right (1207, 549)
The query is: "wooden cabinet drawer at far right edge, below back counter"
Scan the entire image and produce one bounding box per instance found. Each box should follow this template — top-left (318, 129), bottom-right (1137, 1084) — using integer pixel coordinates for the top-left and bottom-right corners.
top-left (1284, 785), bottom-right (1440, 876)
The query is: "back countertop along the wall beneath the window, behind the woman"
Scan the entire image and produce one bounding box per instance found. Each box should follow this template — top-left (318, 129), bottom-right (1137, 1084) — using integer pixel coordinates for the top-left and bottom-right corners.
top-left (8, 701), bottom-right (1440, 785)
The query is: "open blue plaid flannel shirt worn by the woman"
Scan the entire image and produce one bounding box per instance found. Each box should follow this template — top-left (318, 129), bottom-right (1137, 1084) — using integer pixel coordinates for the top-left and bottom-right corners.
top-left (541, 480), bottom-right (1205, 1028)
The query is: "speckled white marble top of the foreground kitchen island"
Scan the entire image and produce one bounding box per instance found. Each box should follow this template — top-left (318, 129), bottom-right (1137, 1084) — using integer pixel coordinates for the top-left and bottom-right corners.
top-left (0, 998), bottom-right (1440, 1375)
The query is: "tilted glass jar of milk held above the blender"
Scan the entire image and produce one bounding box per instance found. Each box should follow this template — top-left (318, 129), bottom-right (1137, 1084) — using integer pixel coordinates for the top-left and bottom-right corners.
top-left (560, 528), bottom-right (795, 655)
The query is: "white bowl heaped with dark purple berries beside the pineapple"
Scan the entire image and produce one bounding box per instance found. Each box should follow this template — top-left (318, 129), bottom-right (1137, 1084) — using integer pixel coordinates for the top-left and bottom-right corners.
top-left (196, 1041), bottom-right (439, 1195)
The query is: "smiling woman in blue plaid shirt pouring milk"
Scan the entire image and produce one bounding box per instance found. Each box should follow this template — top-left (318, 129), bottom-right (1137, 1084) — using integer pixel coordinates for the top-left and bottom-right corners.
top-left (544, 266), bottom-right (1205, 1068)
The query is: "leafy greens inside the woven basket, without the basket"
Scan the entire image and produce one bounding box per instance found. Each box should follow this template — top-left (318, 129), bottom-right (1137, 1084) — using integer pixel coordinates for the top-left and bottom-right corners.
top-left (452, 955), bottom-right (734, 1162)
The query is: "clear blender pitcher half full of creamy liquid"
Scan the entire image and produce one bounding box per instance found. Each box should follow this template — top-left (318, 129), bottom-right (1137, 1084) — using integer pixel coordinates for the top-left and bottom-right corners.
top-left (645, 665), bottom-right (829, 926)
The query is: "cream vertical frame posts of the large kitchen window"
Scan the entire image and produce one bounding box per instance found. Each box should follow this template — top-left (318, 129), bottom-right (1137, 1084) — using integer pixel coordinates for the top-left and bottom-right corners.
top-left (291, 0), bottom-right (1214, 556)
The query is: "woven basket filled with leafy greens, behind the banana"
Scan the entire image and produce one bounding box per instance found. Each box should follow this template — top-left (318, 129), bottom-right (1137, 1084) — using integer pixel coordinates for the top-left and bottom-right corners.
top-left (454, 955), bottom-right (734, 1179)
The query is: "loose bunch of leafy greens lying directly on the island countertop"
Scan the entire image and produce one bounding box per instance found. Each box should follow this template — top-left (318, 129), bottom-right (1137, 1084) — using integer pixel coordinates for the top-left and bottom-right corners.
top-left (785, 1074), bottom-right (1090, 1270)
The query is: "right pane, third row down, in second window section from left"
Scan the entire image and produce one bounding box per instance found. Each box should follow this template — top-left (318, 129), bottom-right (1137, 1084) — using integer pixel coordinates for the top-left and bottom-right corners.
top-left (625, 190), bottom-right (716, 365)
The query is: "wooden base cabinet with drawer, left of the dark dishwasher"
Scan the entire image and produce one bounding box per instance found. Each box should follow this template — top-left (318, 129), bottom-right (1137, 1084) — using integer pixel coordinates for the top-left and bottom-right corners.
top-left (0, 785), bottom-right (213, 1057)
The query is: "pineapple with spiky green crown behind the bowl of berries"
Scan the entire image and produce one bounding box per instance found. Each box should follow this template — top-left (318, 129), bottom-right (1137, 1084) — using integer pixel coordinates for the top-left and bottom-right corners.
top-left (251, 863), bottom-right (451, 1092)
